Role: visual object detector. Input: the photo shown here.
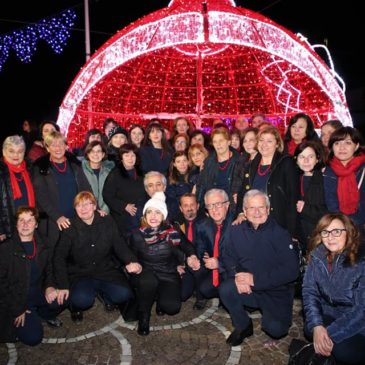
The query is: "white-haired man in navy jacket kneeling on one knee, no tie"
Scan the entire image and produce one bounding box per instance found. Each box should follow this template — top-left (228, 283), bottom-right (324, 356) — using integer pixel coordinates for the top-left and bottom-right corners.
top-left (219, 190), bottom-right (299, 346)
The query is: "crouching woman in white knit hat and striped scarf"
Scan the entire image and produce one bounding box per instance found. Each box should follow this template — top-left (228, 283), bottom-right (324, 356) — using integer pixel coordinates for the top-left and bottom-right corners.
top-left (130, 192), bottom-right (200, 336)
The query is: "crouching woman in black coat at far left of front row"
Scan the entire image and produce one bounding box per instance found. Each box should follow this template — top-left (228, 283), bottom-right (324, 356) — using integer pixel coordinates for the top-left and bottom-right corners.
top-left (0, 206), bottom-right (62, 346)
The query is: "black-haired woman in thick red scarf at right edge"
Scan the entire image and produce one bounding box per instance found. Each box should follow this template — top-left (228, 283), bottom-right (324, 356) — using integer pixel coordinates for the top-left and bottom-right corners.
top-left (323, 127), bottom-right (365, 224)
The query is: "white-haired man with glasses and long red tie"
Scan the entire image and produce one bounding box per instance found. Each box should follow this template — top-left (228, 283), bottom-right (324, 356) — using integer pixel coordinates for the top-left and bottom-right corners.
top-left (194, 189), bottom-right (231, 309)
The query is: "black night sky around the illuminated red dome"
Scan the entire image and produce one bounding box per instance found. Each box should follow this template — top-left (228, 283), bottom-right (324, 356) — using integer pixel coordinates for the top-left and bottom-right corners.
top-left (0, 0), bottom-right (365, 139)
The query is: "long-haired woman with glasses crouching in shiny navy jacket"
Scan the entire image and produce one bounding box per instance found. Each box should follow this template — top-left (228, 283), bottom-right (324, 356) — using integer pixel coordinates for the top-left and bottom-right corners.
top-left (303, 213), bottom-right (365, 364)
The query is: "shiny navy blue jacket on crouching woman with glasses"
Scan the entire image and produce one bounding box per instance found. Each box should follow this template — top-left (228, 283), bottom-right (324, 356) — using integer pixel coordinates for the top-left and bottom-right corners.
top-left (303, 244), bottom-right (365, 343)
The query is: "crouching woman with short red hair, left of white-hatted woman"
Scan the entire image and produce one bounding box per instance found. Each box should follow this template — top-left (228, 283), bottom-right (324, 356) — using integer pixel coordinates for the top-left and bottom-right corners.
top-left (53, 191), bottom-right (142, 322)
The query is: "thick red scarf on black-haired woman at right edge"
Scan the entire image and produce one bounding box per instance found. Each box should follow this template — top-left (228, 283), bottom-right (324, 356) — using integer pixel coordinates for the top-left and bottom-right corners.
top-left (330, 155), bottom-right (365, 214)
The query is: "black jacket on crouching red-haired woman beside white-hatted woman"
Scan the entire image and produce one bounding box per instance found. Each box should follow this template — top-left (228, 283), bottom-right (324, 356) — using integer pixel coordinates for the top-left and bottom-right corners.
top-left (53, 212), bottom-right (137, 289)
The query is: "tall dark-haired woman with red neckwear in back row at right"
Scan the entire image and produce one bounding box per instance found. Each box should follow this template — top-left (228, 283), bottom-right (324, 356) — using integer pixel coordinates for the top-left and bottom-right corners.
top-left (284, 113), bottom-right (319, 156)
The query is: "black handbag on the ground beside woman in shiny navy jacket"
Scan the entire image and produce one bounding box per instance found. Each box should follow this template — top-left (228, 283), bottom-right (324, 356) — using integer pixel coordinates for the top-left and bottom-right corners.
top-left (288, 338), bottom-right (336, 365)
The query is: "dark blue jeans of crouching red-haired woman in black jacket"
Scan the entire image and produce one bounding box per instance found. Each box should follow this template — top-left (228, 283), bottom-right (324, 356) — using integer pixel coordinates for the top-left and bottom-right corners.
top-left (70, 278), bottom-right (133, 310)
